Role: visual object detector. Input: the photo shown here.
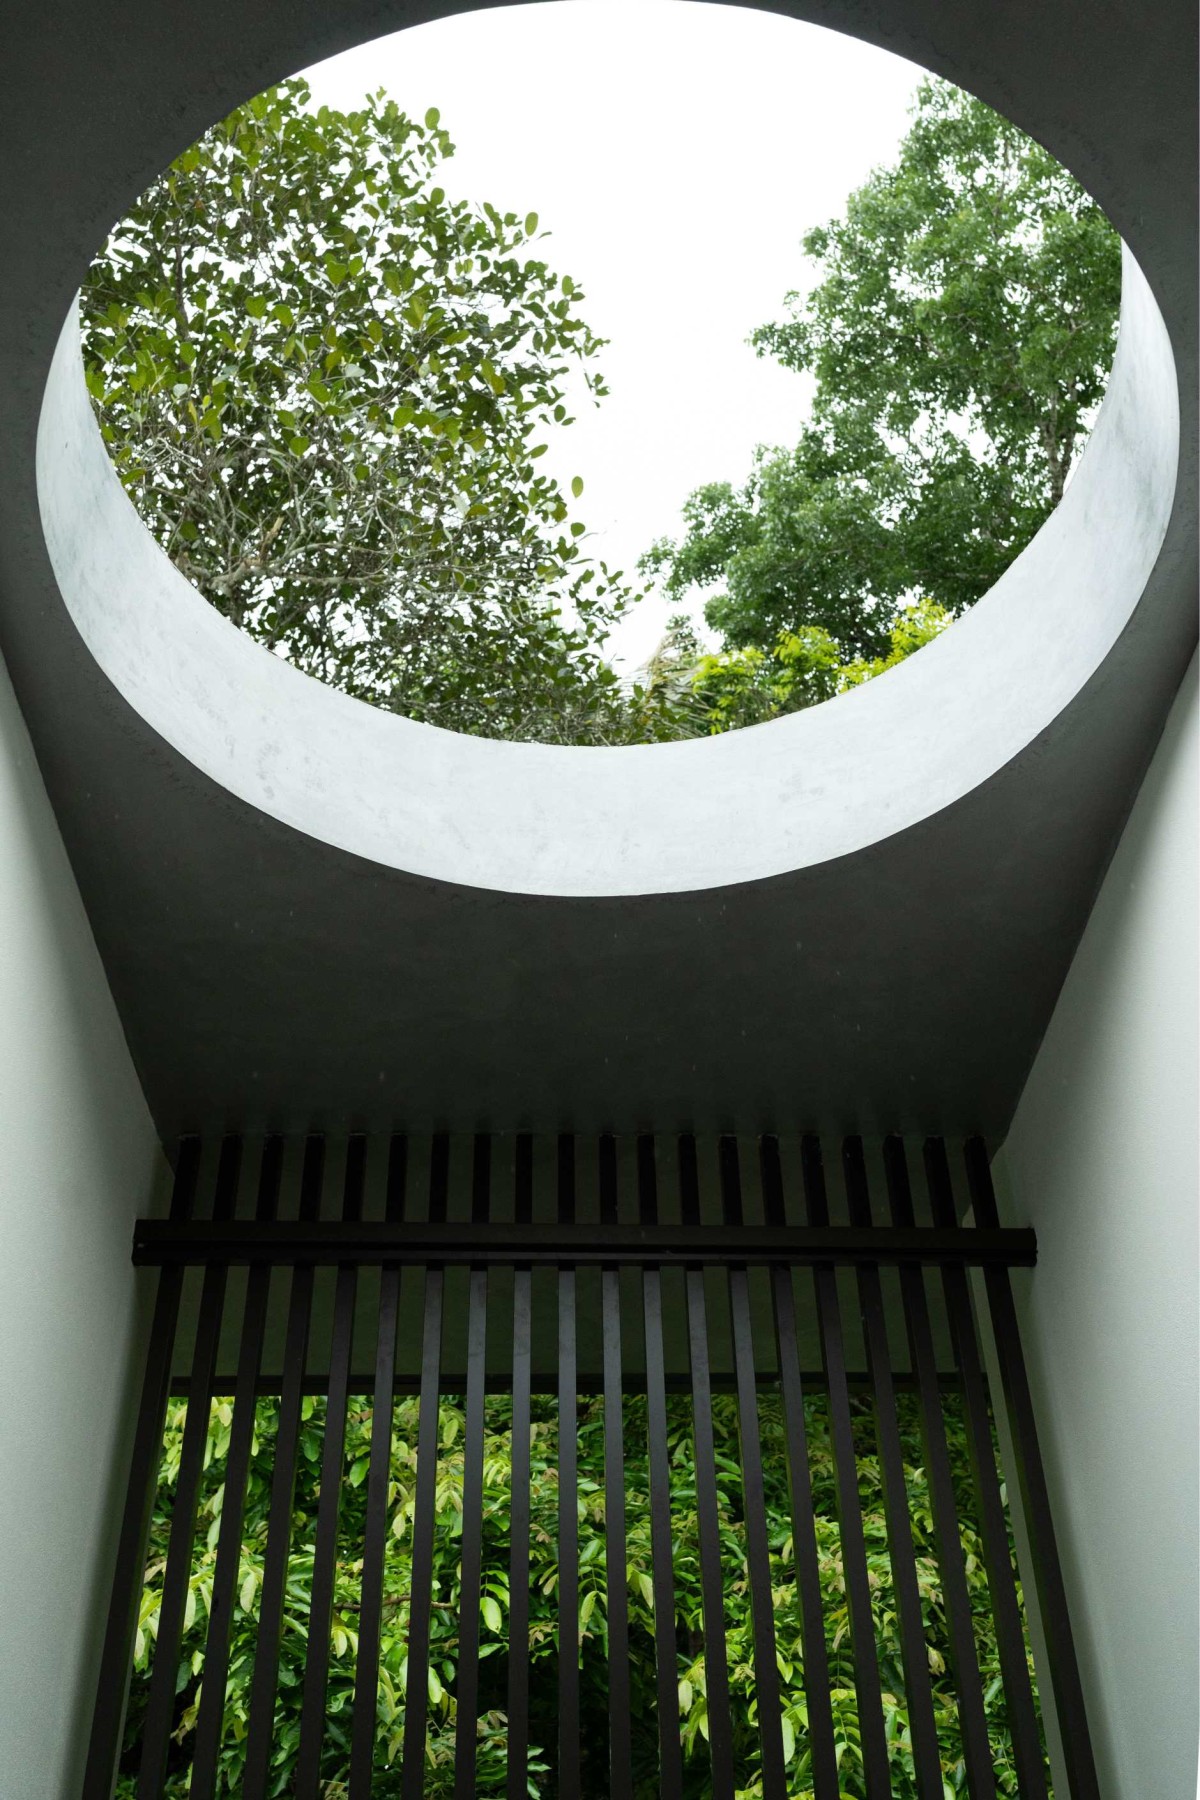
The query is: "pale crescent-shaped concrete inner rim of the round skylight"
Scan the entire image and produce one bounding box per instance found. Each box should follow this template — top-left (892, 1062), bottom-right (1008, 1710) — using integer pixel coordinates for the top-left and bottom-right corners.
top-left (38, 250), bottom-right (1178, 898)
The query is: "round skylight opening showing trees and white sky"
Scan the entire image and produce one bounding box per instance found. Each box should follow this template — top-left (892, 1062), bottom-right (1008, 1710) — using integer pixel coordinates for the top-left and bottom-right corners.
top-left (81, 0), bottom-right (1119, 745)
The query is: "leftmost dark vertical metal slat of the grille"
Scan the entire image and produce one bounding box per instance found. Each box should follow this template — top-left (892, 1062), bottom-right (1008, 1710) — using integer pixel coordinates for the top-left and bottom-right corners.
top-left (83, 1138), bottom-right (200, 1800)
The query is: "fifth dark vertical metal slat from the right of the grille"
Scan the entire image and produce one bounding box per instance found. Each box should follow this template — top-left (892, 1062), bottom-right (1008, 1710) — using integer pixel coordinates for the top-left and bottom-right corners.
top-left (801, 1134), bottom-right (892, 1800)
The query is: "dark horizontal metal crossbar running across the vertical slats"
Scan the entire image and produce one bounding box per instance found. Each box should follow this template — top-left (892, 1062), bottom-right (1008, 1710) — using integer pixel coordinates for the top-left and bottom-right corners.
top-left (133, 1219), bottom-right (1038, 1269)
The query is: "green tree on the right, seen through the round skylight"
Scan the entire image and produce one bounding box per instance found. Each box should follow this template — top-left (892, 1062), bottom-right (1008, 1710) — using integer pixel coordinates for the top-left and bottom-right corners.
top-left (642, 79), bottom-right (1121, 669)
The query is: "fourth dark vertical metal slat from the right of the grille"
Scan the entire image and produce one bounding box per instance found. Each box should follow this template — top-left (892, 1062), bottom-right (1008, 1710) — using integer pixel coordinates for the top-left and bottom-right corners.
top-left (842, 1138), bottom-right (943, 1800)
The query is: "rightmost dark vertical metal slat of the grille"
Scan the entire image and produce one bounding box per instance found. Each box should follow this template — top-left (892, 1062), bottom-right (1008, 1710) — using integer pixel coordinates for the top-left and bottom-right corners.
top-left (966, 1138), bottom-right (1099, 1800)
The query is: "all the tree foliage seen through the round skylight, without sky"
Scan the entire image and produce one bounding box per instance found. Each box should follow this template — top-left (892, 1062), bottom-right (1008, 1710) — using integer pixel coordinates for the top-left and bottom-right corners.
top-left (83, 79), bottom-right (1119, 743)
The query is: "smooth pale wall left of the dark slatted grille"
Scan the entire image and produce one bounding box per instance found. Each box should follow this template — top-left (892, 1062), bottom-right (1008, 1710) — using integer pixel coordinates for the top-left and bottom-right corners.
top-left (0, 668), bottom-right (160, 1800)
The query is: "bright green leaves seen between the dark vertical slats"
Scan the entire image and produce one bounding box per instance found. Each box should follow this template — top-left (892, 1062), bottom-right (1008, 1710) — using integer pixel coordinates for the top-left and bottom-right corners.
top-left (119, 1391), bottom-right (1043, 1800)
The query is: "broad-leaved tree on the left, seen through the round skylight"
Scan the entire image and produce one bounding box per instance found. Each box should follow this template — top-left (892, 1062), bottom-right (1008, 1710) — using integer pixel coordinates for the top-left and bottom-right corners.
top-left (81, 79), bottom-right (653, 742)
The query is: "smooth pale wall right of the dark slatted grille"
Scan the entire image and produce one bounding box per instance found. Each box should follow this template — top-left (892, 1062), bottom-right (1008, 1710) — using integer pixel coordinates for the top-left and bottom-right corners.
top-left (997, 659), bottom-right (1200, 1800)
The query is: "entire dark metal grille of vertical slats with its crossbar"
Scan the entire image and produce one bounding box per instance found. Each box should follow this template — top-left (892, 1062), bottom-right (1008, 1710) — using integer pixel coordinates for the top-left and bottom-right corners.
top-left (83, 1134), bottom-right (1099, 1800)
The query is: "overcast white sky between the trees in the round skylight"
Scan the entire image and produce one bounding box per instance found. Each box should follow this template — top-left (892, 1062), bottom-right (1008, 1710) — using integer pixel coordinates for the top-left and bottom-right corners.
top-left (306, 0), bottom-right (921, 668)
